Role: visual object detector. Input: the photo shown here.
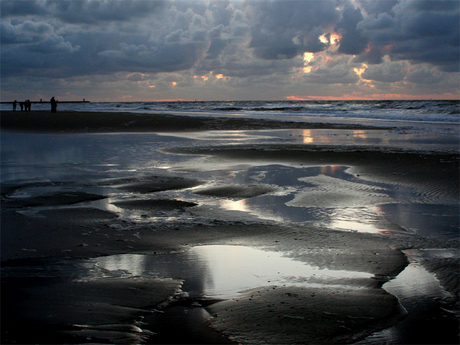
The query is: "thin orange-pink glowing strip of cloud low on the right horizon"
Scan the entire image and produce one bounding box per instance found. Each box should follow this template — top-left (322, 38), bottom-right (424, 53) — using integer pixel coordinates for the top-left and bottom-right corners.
top-left (286, 92), bottom-right (460, 101)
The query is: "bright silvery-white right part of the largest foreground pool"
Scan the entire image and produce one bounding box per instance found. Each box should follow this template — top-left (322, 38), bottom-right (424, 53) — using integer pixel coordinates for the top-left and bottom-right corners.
top-left (190, 245), bottom-right (372, 297)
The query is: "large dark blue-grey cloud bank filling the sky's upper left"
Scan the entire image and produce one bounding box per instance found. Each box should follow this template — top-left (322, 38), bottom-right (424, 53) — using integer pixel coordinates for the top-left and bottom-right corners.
top-left (1, 1), bottom-right (207, 78)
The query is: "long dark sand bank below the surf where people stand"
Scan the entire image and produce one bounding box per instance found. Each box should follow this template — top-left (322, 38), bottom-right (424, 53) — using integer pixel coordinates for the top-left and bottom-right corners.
top-left (1, 111), bottom-right (388, 133)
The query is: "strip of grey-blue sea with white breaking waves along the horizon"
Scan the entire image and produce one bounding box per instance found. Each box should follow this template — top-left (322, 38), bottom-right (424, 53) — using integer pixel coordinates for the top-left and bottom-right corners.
top-left (1, 100), bottom-right (460, 124)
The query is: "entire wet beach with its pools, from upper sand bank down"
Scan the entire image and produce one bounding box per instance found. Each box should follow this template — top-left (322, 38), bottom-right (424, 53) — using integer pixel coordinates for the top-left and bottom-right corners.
top-left (1, 111), bottom-right (459, 344)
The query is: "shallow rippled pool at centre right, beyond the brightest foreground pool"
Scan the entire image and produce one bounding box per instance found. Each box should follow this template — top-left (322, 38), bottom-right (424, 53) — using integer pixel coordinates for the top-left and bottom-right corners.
top-left (189, 164), bottom-right (394, 233)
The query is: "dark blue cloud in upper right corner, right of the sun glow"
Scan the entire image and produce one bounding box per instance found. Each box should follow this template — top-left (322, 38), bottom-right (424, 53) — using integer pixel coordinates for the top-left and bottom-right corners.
top-left (357, 0), bottom-right (460, 72)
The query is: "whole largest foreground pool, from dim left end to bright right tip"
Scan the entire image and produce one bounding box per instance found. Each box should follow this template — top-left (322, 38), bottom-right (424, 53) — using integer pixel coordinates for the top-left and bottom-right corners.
top-left (81, 245), bottom-right (372, 298)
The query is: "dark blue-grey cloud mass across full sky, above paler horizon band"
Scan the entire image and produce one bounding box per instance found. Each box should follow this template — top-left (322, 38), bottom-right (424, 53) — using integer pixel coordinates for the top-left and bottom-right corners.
top-left (0, 0), bottom-right (460, 99)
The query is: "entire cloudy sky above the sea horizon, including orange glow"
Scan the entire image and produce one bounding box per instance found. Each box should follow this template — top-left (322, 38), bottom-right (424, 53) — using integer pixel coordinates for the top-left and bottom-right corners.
top-left (0, 0), bottom-right (460, 102)
